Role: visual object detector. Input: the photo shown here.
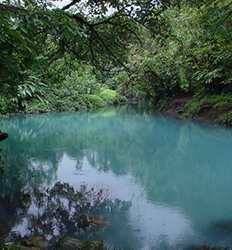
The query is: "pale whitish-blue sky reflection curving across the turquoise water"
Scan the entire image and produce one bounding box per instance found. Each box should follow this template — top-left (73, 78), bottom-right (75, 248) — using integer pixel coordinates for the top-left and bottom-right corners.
top-left (57, 155), bottom-right (195, 249)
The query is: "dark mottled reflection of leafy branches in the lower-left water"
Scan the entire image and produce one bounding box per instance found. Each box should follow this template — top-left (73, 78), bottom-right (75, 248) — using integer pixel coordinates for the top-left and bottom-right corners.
top-left (7, 182), bottom-right (129, 244)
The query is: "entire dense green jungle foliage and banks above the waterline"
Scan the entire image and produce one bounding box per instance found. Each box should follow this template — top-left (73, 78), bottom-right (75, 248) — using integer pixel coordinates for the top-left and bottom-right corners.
top-left (0, 0), bottom-right (232, 125)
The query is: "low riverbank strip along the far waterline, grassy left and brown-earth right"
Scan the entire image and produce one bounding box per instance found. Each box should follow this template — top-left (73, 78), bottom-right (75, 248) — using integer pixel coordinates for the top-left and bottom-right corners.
top-left (0, 93), bottom-right (232, 127)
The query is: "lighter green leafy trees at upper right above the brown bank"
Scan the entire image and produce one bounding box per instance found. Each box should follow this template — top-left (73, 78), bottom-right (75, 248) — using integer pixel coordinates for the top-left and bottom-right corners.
top-left (109, 0), bottom-right (232, 101)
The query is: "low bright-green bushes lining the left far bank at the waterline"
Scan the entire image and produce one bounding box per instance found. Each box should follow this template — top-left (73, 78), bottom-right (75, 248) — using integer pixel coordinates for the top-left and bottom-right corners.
top-left (0, 88), bottom-right (127, 116)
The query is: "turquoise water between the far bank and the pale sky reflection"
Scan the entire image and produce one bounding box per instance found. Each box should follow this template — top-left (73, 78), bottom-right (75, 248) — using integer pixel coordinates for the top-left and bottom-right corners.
top-left (0, 110), bottom-right (232, 241)
